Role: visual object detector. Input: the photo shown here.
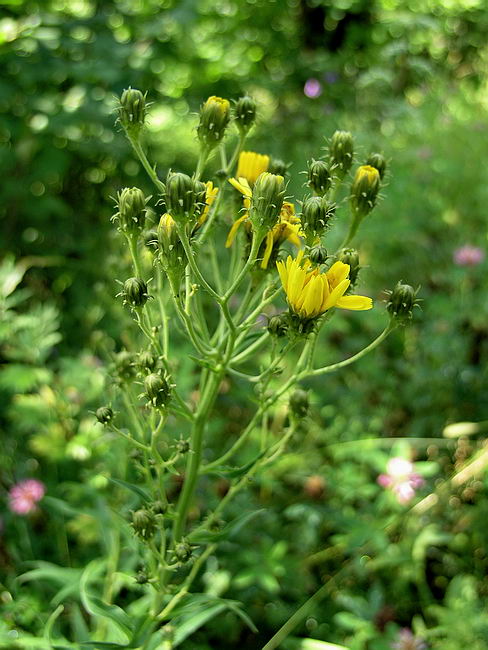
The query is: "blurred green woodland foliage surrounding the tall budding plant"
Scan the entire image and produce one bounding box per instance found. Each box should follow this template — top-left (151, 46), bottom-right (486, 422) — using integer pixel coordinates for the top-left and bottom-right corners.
top-left (0, 0), bottom-right (488, 650)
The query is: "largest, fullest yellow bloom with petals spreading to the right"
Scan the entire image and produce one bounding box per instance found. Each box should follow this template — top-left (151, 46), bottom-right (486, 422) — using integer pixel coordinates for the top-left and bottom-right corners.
top-left (276, 251), bottom-right (373, 318)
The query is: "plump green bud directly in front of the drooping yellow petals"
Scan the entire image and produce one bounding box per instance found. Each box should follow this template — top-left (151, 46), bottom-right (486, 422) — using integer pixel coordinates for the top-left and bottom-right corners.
top-left (249, 172), bottom-right (285, 235)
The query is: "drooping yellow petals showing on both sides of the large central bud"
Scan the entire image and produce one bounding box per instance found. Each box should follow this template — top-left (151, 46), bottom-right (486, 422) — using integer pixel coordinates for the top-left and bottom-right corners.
top-left (225, 177), bottom-right (303, 269)
